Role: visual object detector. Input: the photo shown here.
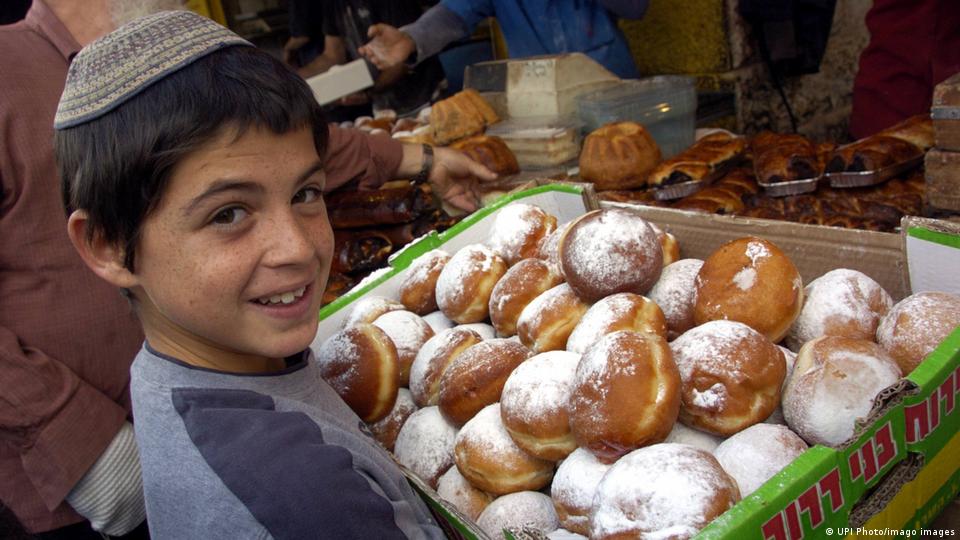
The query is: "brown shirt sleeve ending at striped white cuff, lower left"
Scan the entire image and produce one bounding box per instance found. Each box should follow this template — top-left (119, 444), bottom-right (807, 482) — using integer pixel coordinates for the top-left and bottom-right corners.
top-left (0, 327), bottom-right (127, 509)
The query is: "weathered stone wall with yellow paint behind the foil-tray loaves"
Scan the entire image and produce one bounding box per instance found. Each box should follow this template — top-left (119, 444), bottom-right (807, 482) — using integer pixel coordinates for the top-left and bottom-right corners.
top-left (621, 0), bottom-right (872, 142)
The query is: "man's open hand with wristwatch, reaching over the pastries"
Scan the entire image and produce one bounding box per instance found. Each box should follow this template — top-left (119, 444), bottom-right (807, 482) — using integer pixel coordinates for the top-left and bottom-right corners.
top-left (427, 147), bottom-right (497, 216)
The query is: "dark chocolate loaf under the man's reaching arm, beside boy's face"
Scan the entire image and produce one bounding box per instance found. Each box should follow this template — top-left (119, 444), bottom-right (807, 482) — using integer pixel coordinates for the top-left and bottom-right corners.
top-left (327, 186), bottom-right (436, 229)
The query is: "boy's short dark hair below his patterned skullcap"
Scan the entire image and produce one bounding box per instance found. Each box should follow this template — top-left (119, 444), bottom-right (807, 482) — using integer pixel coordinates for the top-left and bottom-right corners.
top-left (54, 46), bottom-right (328, 271)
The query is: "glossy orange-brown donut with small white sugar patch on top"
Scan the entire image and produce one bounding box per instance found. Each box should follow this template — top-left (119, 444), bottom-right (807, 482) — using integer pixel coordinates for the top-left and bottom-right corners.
top-left (693, 236), bottom-right (803, 343)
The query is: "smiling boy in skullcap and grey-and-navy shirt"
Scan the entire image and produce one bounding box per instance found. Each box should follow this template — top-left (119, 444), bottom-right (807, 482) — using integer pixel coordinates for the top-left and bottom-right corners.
top-left (55, 12), bottom-right (480, 540)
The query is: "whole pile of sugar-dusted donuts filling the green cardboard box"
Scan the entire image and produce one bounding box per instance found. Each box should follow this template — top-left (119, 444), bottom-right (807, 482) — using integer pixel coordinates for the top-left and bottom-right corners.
top-left (317, 203), bottom-right (960, 538)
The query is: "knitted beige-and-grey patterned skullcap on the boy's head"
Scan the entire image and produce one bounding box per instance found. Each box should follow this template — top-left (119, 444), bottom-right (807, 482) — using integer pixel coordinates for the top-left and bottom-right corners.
top-left (53, 11), bottom-right (253, 129)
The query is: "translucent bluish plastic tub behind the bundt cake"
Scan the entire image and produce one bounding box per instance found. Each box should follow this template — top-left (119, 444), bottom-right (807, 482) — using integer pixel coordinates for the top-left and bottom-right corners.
top-left (577, 75), bottom-right (697, 158)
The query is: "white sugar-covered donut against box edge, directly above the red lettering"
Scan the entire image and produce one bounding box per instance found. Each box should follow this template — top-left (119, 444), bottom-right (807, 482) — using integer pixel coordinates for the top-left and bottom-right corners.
top-left (713, 424), bottom-right (807, 497)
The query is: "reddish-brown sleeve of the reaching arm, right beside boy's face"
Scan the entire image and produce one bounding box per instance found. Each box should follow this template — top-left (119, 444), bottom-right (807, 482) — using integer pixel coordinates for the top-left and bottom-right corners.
top-left (326, 124), bottom-right (403, 192)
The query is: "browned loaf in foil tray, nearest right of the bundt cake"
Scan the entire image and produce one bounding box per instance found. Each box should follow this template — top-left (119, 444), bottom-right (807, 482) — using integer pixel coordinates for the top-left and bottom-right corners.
top-left (647, 131), bottom-right (747, 188)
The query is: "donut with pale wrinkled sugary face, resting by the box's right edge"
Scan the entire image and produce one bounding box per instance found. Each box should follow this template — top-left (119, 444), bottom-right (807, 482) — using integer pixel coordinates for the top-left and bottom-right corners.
top-left (783, 336), bottom-right (900, 446)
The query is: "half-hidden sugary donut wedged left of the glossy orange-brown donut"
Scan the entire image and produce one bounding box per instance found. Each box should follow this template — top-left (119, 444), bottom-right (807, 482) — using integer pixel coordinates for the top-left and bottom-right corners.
top-left (649, 259), bottom-right (703, 340)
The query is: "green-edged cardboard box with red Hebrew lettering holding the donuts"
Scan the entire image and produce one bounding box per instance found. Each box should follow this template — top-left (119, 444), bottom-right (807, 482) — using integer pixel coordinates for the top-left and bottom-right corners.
top-left (314, 182), bottom-right (960, 540)
